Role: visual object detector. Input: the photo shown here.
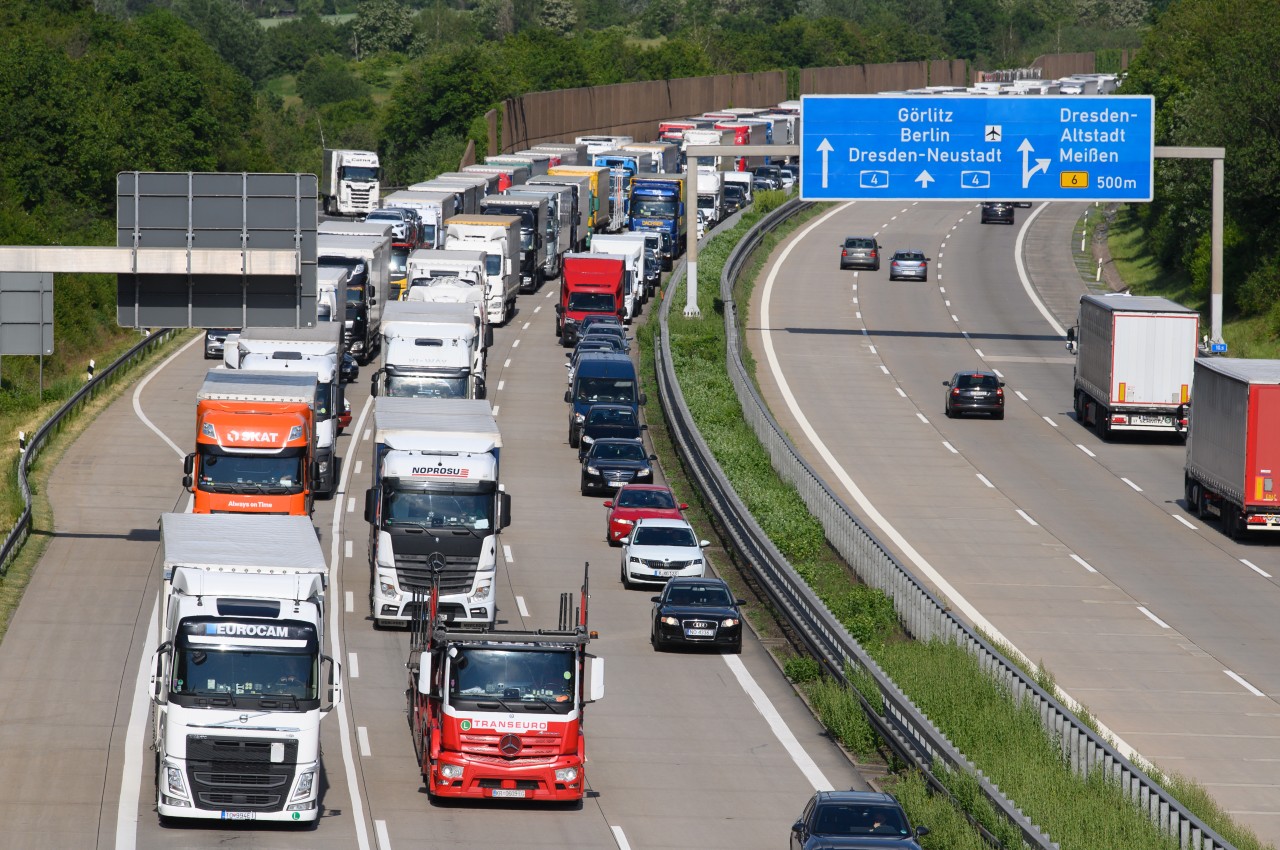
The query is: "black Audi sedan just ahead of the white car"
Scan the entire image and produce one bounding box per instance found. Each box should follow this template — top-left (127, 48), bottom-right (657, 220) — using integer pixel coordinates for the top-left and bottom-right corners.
top-left (649, 577), bottom-right (742, 654)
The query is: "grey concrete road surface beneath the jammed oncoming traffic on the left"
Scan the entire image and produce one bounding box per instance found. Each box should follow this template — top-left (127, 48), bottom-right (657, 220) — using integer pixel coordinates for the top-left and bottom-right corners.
top-left (0, 256), bottom-right (864, 850)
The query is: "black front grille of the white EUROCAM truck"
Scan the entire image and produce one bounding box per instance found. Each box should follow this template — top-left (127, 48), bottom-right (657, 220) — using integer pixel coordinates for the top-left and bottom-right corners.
top-left (187, 735), bottom-right (298, 812)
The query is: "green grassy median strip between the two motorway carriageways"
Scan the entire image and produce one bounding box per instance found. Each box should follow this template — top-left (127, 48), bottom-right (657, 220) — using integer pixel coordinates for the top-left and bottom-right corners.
top-left (640, 200), bottom-right (1263, 850)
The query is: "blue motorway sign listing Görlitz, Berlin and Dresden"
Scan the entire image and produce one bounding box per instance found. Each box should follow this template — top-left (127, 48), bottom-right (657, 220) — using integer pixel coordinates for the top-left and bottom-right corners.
top-left (800, 95), bottom-right (1156, 201)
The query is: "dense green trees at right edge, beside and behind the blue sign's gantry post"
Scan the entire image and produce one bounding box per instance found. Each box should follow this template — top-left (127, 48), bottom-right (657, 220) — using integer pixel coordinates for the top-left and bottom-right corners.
top-left (1125, 0), bottom-right (1280, 329)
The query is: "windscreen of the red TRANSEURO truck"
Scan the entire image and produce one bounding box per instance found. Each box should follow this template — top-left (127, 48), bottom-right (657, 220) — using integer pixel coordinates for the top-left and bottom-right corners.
top-left (447, 646), bottom-right (577, 714)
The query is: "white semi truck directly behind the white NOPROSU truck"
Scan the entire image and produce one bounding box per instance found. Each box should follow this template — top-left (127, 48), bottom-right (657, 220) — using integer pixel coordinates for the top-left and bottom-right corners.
top-left (370, 301), bottom-right (485, 398)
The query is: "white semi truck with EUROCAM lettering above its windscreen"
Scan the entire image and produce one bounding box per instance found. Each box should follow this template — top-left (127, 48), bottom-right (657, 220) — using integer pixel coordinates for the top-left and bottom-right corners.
top-left (151, 513), bottom-right (342, 823)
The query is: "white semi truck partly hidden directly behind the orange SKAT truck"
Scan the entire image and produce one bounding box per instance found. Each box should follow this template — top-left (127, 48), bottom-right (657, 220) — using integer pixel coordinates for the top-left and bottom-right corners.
top-left (223, 321), bottom-right (346, 498)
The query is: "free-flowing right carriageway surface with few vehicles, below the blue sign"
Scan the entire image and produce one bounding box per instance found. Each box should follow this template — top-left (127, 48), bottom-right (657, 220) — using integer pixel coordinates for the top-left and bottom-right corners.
top-left (751, 202), bottom-right (1280, 840)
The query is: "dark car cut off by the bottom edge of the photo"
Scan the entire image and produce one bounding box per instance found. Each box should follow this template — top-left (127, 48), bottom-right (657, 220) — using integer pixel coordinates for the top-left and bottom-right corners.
top-left (791, 791), bottom-right (929, 850)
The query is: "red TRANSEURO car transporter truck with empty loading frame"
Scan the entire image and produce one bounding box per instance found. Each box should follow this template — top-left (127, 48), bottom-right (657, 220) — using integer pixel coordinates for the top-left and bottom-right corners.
top-left (406, 570), bottom-right (604, 803)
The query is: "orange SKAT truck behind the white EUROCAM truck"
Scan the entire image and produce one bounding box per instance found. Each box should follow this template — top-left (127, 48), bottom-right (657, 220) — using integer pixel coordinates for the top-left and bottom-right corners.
top-left (182, 369), bottom-right (316, 516)
